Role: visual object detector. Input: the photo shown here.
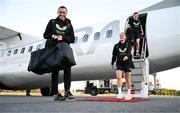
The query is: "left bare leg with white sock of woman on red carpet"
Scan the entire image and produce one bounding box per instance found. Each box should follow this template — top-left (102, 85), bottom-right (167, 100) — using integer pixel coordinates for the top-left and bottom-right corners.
top-left (116, 70), bottom-right (122, 98)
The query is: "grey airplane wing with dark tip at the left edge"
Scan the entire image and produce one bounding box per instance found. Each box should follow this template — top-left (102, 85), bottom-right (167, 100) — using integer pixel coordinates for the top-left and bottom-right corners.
top-left (0, 26), bottom-right (21, 40)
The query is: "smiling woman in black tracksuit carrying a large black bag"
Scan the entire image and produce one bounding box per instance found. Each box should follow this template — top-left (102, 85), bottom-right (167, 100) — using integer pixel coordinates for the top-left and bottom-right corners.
top-left (44, 6), bottom-right (75, 101)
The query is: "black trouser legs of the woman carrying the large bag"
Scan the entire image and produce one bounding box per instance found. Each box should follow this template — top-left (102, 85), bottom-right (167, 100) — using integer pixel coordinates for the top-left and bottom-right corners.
top-left (51, 67), bottom-right (71, 94)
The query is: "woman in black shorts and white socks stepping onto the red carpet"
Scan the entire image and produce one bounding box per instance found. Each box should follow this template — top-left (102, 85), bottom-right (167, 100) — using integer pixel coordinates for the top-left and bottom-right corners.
top-left (111, 32), bottom-right (132, 100)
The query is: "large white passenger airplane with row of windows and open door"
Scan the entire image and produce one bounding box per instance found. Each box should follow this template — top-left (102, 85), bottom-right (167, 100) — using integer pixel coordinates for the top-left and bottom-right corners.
top-left (0, 0), bottom-right (180, 96)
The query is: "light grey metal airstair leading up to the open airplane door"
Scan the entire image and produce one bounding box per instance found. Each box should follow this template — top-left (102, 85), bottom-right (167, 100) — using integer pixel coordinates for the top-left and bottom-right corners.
top-left (122, 38), bottom-right (149, 98)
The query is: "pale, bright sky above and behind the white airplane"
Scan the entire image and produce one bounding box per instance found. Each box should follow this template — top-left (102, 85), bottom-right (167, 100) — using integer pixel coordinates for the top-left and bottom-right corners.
top-left (0, 0), bottom-right (180, 90)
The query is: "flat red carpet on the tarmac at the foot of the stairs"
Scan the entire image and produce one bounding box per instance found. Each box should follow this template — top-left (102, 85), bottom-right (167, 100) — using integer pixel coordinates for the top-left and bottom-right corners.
top-left (78, 97), bottom-right (145, 102)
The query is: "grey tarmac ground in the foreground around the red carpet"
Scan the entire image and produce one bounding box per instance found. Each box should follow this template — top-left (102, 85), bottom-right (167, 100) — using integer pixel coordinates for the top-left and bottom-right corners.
top-left (0, 95), bottom-right (180, 113)
